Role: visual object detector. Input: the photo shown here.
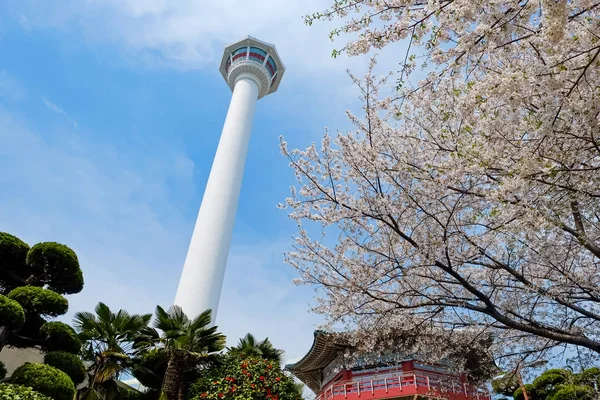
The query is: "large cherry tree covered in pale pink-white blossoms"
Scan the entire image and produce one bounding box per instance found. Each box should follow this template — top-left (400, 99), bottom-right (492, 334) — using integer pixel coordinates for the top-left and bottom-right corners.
top-left (281, 0), bottom-right (600, 372)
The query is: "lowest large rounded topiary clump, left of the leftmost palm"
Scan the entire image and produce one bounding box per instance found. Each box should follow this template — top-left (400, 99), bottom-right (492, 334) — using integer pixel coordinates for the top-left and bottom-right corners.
top-left (11, 363), bottom-right (75, 400)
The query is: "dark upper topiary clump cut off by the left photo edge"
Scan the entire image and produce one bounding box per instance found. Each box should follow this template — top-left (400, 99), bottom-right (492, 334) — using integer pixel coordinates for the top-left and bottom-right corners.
top-left (0, 232), bottom-right (29, 294)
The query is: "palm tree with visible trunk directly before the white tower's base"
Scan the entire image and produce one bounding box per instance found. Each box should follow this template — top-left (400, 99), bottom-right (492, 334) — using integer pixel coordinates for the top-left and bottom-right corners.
top-left (136, 306), bottom-right (225, 400)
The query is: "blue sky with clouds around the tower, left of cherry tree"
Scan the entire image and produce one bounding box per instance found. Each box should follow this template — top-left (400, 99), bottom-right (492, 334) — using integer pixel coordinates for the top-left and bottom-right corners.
top-left (0, 0), bottom-right (384, 361)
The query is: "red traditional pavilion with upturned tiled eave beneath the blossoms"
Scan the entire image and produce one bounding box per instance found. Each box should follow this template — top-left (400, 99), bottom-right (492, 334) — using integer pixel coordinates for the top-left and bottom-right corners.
top-left (285, 331), bottom-right (491, 400)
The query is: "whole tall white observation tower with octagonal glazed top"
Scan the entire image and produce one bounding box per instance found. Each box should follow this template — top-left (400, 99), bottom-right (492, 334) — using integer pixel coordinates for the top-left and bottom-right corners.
top-left (175, 36), bottom-right (285, 324)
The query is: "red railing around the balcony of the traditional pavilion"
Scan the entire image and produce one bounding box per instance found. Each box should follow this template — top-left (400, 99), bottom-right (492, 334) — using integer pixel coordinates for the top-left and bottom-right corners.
top-left (318, 371), bottom-right (491, 400)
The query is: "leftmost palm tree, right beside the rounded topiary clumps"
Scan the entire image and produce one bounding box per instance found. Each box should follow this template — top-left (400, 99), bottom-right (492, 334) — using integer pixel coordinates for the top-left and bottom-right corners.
top-left (73, 303), bottom-right (152, 398)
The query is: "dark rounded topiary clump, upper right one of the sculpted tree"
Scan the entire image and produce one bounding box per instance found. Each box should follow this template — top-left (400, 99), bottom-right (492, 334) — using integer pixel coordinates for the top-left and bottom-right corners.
top-left (27, 242), bottom-right (83, 294)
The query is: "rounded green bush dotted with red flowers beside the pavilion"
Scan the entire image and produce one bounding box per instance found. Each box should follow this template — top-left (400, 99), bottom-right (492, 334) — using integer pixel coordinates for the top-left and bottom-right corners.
top-left (190, 353), bottom-right (302, 400)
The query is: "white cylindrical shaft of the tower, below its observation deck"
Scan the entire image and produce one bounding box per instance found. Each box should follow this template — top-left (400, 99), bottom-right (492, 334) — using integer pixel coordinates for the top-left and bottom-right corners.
top-left (175, 74), bottom-right (260, 324)
